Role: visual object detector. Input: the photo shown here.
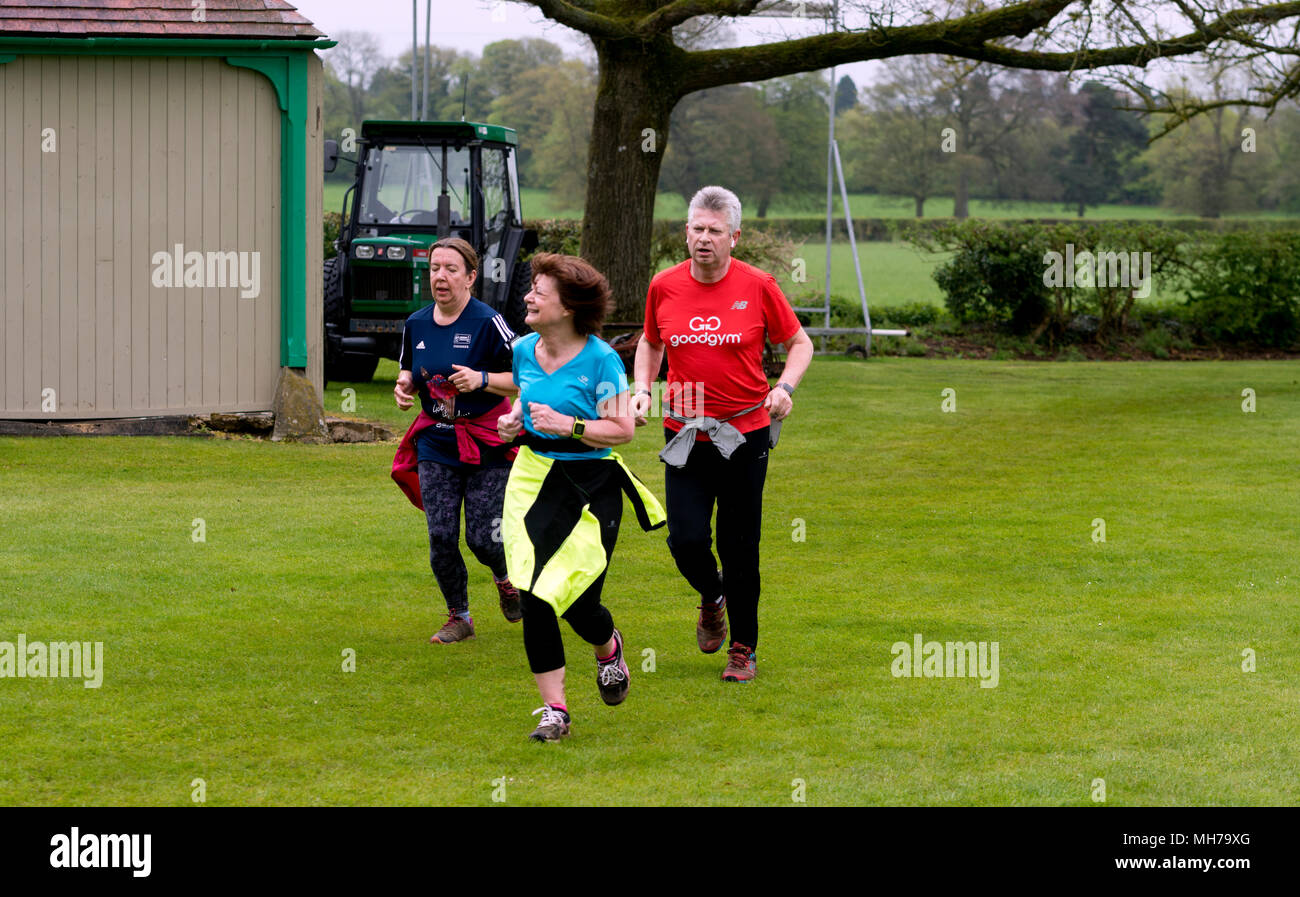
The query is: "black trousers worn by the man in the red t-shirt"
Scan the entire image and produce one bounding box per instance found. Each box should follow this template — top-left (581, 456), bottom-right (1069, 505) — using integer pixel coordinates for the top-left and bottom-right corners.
top-left (664, 426), bottom-right (768, 647)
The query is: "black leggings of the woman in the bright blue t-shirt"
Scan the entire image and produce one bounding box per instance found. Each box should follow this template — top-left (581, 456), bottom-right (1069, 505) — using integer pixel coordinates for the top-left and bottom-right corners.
top-left (516, 462), bottom-right (623, 673)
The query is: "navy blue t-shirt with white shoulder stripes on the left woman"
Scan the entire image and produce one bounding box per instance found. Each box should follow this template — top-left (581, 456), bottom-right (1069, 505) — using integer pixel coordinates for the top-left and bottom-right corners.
top-left (398, 296), bottom-right (515, 467)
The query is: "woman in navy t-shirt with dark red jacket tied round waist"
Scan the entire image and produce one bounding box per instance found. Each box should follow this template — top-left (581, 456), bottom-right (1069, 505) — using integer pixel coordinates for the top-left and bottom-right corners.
top-left (393, 237), bottom-right (523, 645)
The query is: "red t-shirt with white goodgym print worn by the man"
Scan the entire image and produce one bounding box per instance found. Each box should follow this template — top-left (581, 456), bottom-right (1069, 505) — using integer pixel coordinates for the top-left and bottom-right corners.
top-left (646, 259), bottom-right (800, 439)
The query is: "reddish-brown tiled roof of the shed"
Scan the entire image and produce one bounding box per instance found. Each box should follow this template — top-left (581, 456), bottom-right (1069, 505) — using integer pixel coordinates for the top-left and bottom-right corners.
top-left (0, 0), bottom-right (325, 40)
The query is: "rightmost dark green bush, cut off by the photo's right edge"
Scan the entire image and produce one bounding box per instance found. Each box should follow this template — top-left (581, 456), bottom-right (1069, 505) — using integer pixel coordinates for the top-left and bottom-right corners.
top-left (1188, 231), bottom-right (1300, 347)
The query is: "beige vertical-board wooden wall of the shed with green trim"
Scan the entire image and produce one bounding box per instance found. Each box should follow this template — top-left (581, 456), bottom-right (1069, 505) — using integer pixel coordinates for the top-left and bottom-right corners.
top-left (0, 56), bottom-right (283, 420)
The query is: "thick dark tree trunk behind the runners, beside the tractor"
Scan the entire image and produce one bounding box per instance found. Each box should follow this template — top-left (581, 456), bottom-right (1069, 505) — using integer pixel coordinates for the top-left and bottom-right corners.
top-left (580, 39), bottom-right (681, 321)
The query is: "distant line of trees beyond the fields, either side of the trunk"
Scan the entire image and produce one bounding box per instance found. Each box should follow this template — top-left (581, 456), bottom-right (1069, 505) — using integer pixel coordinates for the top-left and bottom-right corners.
top-left (325, 33), bottom-right (1300, 218)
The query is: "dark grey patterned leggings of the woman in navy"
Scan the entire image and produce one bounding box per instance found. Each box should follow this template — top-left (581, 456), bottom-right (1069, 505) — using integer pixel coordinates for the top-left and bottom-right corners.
top-left (417, 462), bottom-right (510, 614)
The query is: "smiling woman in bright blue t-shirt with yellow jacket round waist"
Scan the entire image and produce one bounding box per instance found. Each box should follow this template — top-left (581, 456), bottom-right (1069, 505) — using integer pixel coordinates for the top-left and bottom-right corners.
top-left (497, 252), bottom-right (664, 741)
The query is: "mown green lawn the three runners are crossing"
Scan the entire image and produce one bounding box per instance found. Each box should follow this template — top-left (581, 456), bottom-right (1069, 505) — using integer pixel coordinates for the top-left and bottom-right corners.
top-left (0, 359), bottom-right (1300, 806)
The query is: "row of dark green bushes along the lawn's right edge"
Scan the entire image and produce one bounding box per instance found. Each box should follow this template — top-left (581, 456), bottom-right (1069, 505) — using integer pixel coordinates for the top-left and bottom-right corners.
top-left (909, 221), bottom-right (1300, 348)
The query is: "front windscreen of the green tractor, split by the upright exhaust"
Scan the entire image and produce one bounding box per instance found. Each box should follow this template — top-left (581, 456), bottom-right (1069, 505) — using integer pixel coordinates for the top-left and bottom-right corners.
top-left (358, 146), bottom-right (471, 228)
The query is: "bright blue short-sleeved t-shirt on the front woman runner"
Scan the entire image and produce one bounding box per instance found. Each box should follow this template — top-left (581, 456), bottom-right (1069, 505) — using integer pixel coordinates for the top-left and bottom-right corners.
top-left (514, 333), bottom-right (628, 462)
